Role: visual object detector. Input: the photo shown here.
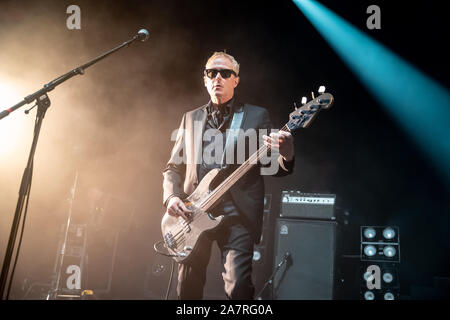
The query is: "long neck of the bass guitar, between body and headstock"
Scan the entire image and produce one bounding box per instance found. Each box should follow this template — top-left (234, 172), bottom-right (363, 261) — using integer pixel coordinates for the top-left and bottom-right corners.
top-left (200, 124), bottom-right (289, 211)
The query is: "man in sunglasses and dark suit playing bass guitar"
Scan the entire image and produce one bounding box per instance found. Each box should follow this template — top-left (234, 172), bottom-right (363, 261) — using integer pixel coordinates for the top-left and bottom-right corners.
top-left (163, 52), bottom-right (294, 299)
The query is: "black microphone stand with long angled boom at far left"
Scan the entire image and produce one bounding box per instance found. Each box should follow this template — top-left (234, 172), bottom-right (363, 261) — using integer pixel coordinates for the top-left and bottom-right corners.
top-left (0, 30), bottom-right (148, 300)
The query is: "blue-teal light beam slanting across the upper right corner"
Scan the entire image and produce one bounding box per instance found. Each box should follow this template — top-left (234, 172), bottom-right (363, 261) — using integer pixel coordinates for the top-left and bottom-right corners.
top-left (293, 0), bottom-right (450, 183)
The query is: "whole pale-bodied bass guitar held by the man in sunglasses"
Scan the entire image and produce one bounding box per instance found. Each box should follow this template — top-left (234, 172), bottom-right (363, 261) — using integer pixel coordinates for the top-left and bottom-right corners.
top-left (161, 86), bottom-right (334, 263)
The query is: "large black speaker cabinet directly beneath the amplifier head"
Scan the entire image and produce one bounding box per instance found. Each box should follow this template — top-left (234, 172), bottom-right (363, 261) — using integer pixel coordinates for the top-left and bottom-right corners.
top-left (273, 218), bottom-right (337, 300)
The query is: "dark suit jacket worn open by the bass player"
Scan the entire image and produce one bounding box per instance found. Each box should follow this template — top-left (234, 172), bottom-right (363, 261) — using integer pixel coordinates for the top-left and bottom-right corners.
top-left (163, 103), bottom-right (294, 243)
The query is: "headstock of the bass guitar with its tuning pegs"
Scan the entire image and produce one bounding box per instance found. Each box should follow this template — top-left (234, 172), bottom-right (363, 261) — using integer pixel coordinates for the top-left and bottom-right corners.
top-left (286, 86), bottom-right (334, 131)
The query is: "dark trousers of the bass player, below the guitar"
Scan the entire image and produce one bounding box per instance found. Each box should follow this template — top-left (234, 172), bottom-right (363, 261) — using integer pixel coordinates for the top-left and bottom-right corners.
top-left (177, 217), bottom-right (255, 300)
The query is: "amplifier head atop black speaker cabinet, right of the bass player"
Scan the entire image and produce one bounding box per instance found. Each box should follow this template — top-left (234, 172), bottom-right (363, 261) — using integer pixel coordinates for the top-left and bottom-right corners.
top-left (272, 191), bottom-right (337, 300)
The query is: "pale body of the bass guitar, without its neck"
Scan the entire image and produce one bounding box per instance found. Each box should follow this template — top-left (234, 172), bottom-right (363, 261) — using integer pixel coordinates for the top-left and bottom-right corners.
top-left (161, 169), bottom-right (223, 263)
